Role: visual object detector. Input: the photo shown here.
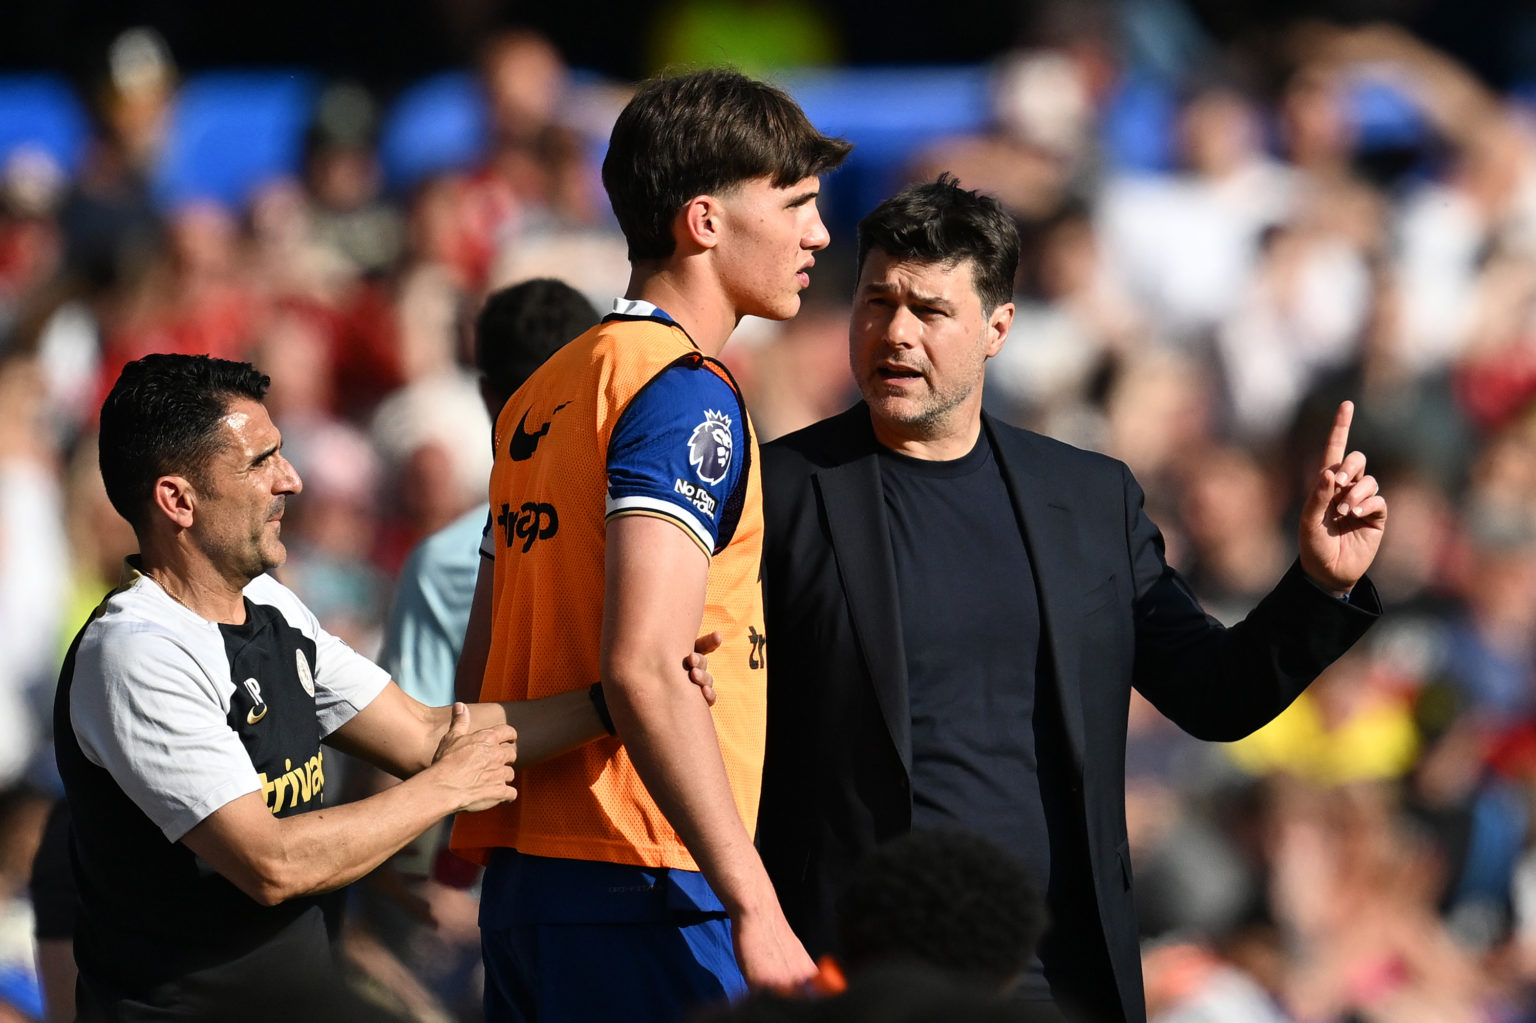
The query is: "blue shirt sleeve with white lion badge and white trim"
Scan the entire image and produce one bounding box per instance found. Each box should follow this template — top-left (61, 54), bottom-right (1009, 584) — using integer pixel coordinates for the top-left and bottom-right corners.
top-left (608, 357), bottom-right (748, 553)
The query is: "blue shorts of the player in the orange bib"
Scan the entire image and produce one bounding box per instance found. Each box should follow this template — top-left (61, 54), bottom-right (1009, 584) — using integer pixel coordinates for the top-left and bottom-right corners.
top-left (479, 849), bottom-right (746, 1023)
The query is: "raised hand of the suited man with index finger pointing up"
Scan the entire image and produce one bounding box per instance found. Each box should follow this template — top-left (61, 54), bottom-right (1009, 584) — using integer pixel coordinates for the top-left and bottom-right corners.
top-left (1298, 401), bottom-right (1387, 594)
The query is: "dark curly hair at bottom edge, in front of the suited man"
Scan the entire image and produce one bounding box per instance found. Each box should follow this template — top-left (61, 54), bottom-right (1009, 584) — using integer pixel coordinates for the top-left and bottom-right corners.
top-left (837, 831), bottom-right (1046, 989)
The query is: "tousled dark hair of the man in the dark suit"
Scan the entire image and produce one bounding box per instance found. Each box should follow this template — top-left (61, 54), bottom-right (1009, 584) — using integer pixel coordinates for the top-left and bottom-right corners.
top-left (859, 174), bottom-right (1018, 312)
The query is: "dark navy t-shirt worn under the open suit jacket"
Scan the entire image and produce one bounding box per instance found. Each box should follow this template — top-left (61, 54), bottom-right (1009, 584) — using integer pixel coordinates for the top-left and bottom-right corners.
top-left (880, 432), bottom-right (1051, 997)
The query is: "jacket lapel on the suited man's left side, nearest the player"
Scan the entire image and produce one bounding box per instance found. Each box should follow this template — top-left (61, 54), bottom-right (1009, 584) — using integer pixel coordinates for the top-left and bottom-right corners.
top-left (816, 404), bottom-right (912, 773)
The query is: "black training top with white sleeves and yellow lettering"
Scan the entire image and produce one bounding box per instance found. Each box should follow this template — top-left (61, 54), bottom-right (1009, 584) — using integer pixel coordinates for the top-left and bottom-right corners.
top-left (54, 567), bottom-right (389, 1001)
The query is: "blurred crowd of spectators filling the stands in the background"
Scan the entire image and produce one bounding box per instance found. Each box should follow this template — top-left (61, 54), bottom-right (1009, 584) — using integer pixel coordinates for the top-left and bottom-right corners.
top-left (0, 5), bottom-right (1536, 1023)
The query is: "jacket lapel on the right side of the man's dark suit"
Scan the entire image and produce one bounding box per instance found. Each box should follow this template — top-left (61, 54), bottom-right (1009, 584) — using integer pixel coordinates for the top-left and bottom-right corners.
top-left (982, 415), bottom-right (1084, 777)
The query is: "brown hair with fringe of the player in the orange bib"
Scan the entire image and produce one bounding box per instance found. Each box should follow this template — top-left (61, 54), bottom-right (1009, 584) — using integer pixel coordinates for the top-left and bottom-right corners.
top-left (602, 68), bottom-right (852, 261)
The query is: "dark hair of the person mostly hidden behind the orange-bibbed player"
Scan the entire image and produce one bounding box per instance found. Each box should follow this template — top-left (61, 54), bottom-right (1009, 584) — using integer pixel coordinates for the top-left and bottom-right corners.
top-left (475, 276), bottom-right (598, 402)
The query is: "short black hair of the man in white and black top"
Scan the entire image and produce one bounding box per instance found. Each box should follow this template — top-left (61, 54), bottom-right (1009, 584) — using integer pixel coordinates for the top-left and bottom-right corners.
top-left (100, 355), bottom-right (272, 530)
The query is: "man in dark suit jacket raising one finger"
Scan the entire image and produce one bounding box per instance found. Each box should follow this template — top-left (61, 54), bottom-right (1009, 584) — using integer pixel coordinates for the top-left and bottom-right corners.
top-left (759, 175), bottom-right (1387, 1020)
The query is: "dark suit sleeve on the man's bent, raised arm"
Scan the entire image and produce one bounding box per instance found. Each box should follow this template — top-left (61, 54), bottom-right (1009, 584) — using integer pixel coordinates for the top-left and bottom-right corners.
top-left (1121, 457), bottom-right (1381, 742)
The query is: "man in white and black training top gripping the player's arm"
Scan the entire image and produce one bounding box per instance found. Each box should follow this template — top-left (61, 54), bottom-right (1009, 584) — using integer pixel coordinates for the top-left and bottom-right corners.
top-left (54, 355), bottom-right (660, 1021)
